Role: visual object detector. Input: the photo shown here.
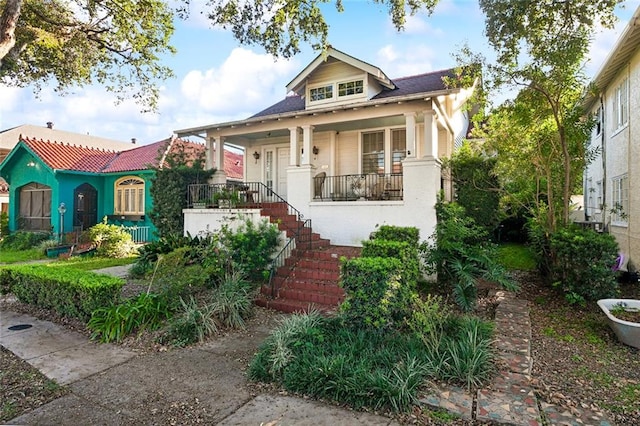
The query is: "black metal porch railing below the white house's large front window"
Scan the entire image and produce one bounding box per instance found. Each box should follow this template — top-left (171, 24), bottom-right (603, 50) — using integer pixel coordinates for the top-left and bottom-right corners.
top-left (313, 173), bottom-right (403, 201)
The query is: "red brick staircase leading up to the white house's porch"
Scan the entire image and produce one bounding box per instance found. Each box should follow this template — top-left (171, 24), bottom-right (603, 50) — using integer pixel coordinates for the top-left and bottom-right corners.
top-left (255, 203), bottom-right (361, 313)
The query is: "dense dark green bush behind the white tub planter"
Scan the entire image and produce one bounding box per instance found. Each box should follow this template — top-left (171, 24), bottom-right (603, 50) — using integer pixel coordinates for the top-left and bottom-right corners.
top-left (549, 227), bottom-right (619, 304)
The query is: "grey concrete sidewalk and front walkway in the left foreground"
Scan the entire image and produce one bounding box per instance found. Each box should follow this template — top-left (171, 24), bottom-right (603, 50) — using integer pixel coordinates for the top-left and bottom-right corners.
top-left (0, 309), bottom-right (398, 426)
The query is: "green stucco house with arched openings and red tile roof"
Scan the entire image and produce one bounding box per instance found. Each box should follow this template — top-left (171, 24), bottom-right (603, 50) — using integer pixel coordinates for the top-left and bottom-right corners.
top-left (0, 137), bottom-right (241, 242)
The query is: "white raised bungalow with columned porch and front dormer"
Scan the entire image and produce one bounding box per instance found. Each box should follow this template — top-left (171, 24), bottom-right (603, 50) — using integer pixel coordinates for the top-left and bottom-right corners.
top-left (176, 48), bottom-right (473, 246)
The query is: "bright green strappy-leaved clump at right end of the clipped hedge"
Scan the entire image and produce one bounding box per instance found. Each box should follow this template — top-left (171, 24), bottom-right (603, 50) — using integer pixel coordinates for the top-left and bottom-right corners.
top-left (87, 293), bottom-right (171, 343)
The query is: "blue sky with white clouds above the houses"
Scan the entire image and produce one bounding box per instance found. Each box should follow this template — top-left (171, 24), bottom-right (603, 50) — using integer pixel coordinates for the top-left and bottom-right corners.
top-left (0, 0), bottom-right (640, 144)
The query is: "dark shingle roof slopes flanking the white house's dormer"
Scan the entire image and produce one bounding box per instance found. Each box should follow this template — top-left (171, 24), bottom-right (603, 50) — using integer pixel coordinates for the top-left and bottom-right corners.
top-left (250, 69), bottom-right (455, 118)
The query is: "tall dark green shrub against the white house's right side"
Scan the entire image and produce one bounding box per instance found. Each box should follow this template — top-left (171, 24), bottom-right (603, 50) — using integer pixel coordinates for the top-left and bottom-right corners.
top-left (449, 142), bottom-right (500, 232)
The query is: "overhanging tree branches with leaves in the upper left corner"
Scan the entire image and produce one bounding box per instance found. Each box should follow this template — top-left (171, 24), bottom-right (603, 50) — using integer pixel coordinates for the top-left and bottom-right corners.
top-left (0, 0), bottom-right (175, 110)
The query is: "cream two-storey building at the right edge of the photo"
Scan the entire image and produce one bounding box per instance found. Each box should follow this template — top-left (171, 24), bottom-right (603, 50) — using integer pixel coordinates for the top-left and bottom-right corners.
top-left (584, 8), bottom-right (640, 267)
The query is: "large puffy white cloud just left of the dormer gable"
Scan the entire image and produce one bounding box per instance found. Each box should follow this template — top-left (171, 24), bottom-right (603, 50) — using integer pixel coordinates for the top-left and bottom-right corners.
top-left (181, 48), bottom-right (298, 116)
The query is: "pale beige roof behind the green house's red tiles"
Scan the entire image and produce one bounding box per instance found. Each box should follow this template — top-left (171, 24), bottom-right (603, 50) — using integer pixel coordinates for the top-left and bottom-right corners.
top-left (0, 124), bottom-right (132, 151)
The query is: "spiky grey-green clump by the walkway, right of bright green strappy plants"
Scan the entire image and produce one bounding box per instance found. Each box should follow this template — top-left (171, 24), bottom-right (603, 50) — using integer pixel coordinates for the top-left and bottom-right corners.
top-left (162, 297), bottom-right (218, 347)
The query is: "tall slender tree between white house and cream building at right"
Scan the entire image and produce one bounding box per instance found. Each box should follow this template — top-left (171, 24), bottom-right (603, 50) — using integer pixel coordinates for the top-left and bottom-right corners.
top-left (464, 0), bottom-right (620, 232)
